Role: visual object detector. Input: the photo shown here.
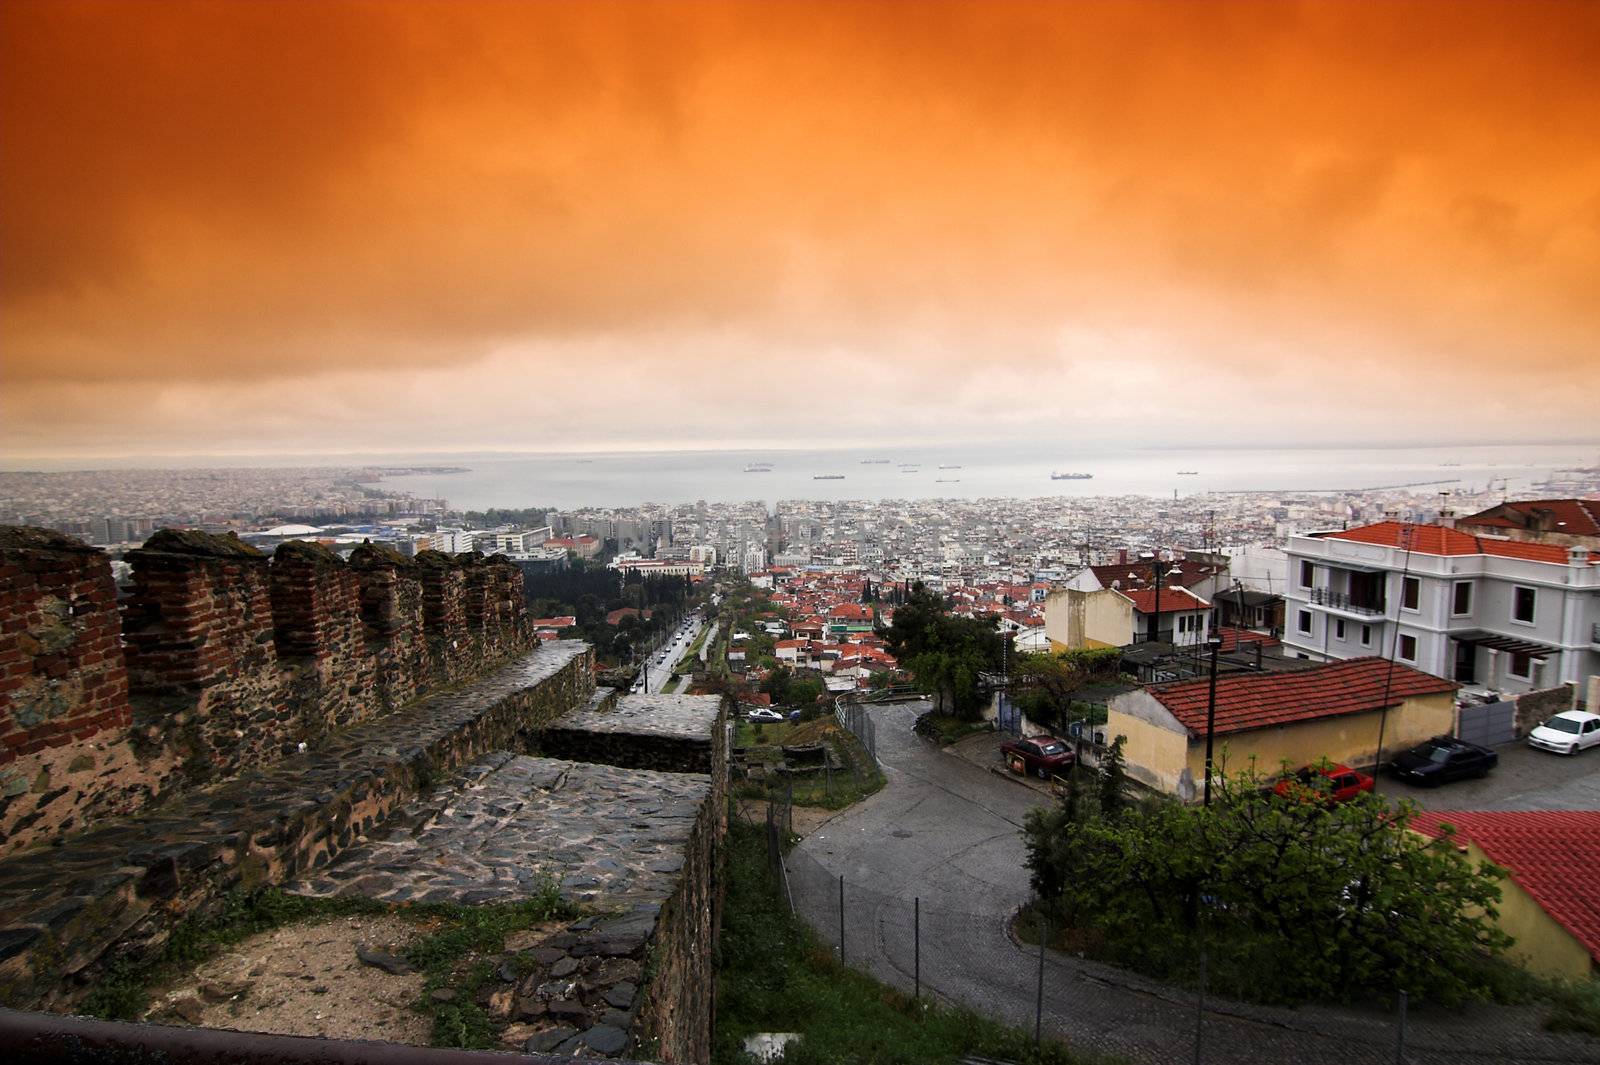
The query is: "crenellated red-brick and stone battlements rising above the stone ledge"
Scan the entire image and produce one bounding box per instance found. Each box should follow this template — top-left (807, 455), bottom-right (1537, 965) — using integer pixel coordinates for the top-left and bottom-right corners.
top-left (0, 526), bottom-right (534, 854)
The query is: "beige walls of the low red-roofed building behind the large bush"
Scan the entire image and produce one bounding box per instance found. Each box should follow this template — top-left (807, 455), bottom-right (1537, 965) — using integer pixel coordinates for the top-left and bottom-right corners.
top-left (1106, 691), bottom-right (1454, 801)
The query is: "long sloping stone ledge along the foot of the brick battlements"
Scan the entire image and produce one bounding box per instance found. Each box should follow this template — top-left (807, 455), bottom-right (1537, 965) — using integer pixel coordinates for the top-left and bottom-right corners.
top-left (0, 641), bottom-right (594, 1009)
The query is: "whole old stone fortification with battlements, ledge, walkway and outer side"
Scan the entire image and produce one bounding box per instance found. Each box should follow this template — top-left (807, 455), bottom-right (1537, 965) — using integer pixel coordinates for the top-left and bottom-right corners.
top-left (0, 526), bottom-right (728, 1062)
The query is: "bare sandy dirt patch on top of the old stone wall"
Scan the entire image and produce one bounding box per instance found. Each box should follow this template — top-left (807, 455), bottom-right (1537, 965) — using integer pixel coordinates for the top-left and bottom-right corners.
top-left (150, 916), bottom-right (432, 1046)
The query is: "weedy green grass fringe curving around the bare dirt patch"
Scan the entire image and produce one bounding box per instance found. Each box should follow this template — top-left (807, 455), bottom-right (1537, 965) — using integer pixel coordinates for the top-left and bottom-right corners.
top-left (83, 883), bottom-right (578, 1049)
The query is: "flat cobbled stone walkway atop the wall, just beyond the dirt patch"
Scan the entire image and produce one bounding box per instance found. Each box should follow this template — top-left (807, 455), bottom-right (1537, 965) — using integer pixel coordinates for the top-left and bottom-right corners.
top-left (293, 752), bottom-right (710, 910)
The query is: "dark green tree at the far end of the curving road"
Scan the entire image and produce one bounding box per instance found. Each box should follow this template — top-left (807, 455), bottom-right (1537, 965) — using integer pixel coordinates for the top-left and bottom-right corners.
top-left (882, 582), bottom-right (1005, 718)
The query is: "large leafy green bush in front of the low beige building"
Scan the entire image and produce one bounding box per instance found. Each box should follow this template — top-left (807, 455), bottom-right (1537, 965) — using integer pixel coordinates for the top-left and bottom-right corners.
top-left (1024, 757), bottom-right (1510, 1003)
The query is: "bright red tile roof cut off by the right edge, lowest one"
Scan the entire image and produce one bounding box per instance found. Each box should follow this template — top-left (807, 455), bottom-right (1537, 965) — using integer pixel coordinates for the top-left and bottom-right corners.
top-left (1411, 809), bottom-right (1600, 961)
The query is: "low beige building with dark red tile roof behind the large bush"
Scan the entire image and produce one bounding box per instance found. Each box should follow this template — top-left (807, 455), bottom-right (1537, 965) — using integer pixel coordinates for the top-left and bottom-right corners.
top-left (1106, 657), bottom-right (1456, 801)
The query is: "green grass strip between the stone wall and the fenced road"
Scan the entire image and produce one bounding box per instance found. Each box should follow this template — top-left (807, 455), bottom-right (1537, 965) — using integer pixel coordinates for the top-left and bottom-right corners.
top-left (712, 822), bottom-right (1091, 1065)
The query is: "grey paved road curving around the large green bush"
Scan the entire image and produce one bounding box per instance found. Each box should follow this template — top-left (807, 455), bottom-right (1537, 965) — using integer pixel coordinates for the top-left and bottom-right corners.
top-left (789, 704), bottom-right (1600, 1065)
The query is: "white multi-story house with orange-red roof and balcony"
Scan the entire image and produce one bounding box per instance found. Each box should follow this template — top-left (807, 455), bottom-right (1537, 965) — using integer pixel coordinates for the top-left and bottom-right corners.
top-left (1283, 521), bottom-right (1600, 694)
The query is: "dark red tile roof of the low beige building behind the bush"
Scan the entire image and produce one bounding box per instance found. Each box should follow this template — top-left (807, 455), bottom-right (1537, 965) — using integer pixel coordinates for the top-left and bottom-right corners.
top-left (1147, 657), bottom-right (1456, 734)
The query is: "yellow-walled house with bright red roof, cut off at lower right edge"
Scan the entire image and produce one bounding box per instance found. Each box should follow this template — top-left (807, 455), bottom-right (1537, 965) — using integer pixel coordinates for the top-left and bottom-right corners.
top-left (1411, 809), bottom-right (1600, 980)
